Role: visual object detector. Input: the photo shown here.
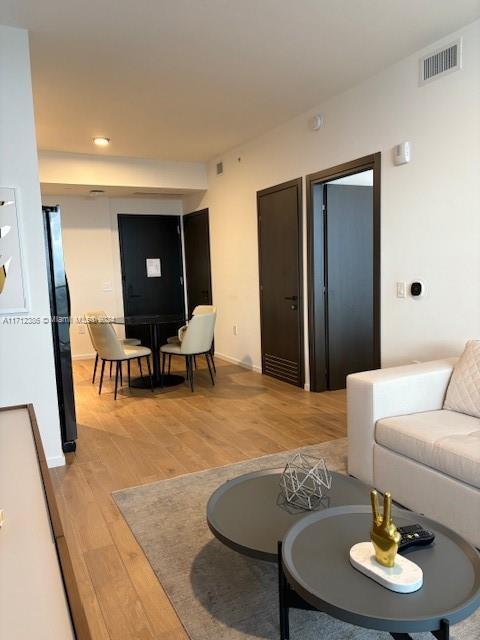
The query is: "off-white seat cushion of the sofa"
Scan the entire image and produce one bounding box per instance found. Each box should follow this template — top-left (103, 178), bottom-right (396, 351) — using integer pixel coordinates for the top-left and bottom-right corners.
top-left (375, 410), bottom-right (480, 488)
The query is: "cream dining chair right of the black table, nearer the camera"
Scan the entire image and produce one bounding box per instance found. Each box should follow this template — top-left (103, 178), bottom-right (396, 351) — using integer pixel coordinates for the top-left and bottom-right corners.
top-left (160, 307), bottom-right (217, 391)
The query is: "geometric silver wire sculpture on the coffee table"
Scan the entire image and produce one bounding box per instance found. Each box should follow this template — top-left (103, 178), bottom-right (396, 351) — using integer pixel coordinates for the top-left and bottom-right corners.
top-left (280, 453), bottom-right (332, 511)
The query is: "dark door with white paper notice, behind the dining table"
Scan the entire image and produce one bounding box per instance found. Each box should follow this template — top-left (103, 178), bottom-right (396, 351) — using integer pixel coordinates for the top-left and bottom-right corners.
top-left (118, 214), bottom-right (185, 345)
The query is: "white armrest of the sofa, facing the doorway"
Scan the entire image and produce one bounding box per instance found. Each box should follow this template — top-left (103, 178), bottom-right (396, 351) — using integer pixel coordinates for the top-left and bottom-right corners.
top-left (347, 358), bottom-right (457, 485)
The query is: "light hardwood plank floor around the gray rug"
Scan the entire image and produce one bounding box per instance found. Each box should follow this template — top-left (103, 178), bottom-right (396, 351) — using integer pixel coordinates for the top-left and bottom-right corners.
top-left (52, 359), bottom-right (346, 640)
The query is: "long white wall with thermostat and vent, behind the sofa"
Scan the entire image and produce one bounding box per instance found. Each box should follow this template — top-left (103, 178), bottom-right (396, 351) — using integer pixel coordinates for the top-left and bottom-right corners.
top-left (185, 21), bottom-right (480, 380)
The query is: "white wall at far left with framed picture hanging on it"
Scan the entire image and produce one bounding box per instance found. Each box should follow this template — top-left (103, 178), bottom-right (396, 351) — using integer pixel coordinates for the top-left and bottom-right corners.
top-left (0, 26), bottom-right (64, 465)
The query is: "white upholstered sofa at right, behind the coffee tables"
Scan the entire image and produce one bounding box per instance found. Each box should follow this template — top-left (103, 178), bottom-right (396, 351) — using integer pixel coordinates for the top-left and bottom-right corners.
top-left (347, 358), bottom-right (480, 547)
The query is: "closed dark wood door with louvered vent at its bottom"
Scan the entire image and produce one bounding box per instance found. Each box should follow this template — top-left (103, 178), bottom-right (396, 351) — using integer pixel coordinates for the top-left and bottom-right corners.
top-left (257, 178), bottom-right (304, 386)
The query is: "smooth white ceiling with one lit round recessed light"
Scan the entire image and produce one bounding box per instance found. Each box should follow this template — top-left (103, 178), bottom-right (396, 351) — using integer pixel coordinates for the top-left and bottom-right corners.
top-left (0, 0), bottom-right (480, 161)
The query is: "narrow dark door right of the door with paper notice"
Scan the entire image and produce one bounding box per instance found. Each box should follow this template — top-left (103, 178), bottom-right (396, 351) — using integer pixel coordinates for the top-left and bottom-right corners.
top-left (183, 209), bottom-right (212, 316)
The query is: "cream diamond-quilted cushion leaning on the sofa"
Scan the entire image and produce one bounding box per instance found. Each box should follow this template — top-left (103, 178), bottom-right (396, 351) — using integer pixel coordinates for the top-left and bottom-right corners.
top-left (443, 340), bottom-right (480, 418)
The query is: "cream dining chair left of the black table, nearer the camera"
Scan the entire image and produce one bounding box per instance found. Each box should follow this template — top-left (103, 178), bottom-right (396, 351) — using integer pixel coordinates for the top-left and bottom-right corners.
top-left (86, 318), bottom-right (153, 400)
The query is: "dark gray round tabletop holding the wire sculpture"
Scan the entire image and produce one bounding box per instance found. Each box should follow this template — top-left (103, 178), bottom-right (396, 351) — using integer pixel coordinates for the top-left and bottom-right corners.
top-left (207, 469), bottom-right (370, 562)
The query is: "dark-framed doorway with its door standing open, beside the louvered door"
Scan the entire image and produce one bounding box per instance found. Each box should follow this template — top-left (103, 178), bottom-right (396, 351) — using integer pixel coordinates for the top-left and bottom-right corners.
top-left (306, 153), bottom-right (381, 391)
